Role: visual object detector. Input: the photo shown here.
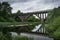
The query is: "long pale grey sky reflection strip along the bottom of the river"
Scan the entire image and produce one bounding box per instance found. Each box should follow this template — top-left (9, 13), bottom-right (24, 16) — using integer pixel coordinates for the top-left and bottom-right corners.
top-left (21, 33), bottom-right (53, 40)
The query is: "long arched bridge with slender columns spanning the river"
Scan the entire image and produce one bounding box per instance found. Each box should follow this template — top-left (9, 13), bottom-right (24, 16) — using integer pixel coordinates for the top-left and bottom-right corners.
top-left (14, 10), bottom-right (50, 22)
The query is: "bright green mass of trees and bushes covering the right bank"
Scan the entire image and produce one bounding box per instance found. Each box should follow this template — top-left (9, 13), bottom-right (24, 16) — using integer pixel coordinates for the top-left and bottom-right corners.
top-left (46, 7), bottom-right (60, 40)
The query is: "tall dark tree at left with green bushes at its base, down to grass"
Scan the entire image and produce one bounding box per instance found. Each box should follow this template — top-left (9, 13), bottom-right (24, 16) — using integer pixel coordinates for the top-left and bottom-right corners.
top-left (0, 2), bottom-right (14, 22)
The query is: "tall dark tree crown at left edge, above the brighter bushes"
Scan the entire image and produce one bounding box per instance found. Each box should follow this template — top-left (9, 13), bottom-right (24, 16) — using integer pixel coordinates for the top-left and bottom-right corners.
top-left (0, 2), bottom-right (12, 18)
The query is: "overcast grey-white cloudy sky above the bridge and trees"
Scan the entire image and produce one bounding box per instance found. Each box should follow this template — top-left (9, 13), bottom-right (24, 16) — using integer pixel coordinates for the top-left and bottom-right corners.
top-left (0, 0), bottom-right (60, 12)
